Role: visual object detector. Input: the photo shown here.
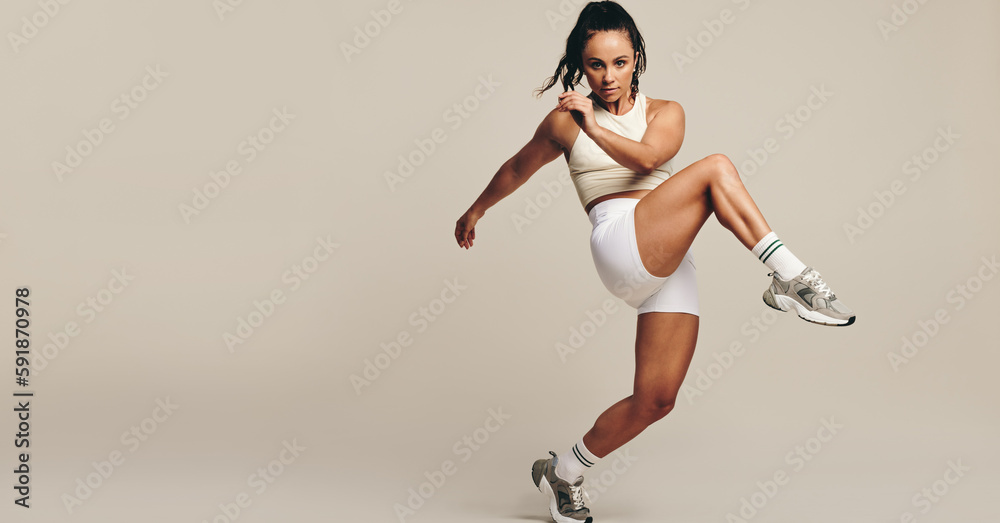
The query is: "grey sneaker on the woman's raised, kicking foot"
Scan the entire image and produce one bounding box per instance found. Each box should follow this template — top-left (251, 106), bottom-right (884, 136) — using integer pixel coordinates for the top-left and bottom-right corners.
top-left (764, 267), bottom-right (854, 327)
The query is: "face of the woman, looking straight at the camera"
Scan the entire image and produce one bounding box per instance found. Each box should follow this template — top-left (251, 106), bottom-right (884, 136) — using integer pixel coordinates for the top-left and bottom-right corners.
top-left (583, 31), bottom-right (637, 103)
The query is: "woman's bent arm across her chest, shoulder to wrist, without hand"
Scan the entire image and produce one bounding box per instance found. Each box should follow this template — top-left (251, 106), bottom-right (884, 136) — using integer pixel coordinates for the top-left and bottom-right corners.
top-left (588, 100), bottom-right (684, 174)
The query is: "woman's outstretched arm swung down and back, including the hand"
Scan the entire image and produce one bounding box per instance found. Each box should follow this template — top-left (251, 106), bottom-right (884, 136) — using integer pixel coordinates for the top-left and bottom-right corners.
top-left (455, 110), bottom-right (563, 249)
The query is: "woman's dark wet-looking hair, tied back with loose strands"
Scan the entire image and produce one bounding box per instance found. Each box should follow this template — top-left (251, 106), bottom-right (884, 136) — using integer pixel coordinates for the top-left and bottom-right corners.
top-left (535, 1), bottom-right (646, 103)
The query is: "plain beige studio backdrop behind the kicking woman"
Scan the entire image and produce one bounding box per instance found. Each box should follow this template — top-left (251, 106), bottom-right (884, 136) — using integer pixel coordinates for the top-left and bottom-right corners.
top-left (0, 0), bottom-right (1000, 523)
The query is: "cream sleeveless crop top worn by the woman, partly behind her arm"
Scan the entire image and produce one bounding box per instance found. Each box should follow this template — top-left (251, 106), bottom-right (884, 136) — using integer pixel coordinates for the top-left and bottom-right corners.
top-left (567, 92), bottom-right (674, 208)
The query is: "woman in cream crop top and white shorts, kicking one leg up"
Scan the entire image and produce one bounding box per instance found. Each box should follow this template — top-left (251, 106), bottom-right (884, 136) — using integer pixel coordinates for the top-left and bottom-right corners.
top-left (455, 1), bottom-right (854, 522)
